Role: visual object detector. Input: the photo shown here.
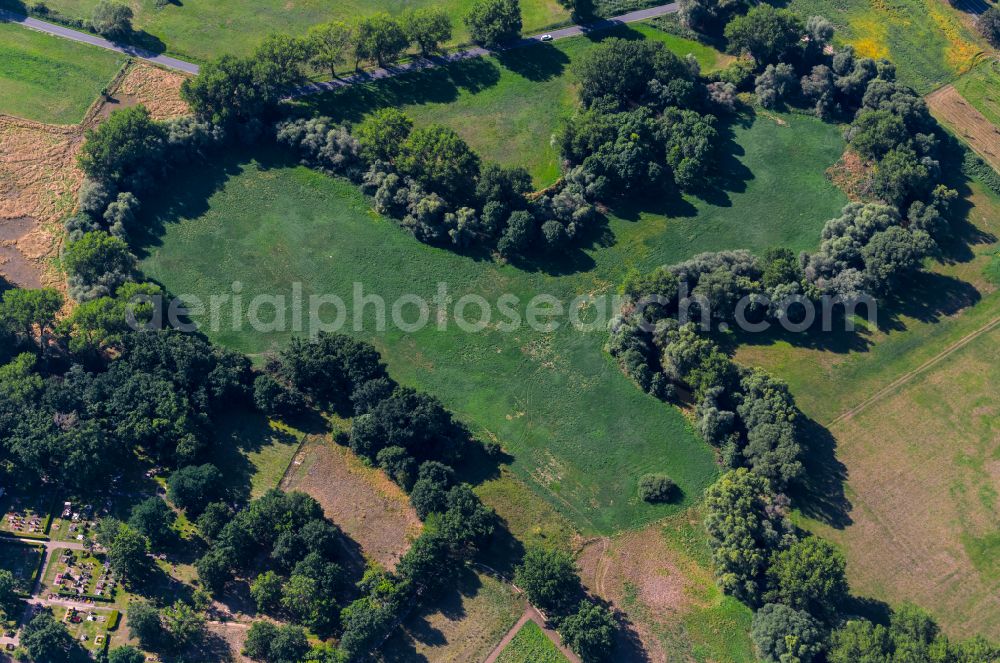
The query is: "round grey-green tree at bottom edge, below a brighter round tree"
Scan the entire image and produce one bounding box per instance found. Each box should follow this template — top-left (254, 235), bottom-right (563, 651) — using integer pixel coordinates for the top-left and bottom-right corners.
top-left (750, 603), bottom-right (823, 663)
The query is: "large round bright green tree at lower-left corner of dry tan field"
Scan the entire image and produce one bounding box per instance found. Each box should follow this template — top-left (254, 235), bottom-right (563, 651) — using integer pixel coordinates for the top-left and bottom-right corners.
top-left (765, 536), bottom-right (847, 617)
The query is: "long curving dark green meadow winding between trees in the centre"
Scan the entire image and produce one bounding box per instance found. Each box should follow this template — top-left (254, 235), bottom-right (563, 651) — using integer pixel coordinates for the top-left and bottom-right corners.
top-left (137, 106), bottom-right (844, 532)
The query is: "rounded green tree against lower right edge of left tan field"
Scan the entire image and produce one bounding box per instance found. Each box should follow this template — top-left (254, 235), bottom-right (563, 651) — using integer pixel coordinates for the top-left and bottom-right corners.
top-left (63, 231), bottom-right (135, 301)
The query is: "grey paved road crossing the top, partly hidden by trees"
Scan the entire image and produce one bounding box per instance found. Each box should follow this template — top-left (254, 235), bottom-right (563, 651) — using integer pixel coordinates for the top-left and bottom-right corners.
top-left (0, 2), bottom-right (678, 85)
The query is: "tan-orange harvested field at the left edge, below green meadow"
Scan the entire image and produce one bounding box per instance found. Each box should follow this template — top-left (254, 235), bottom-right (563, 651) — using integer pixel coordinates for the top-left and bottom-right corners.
top-left (0, 115), bottom-right (83, 288)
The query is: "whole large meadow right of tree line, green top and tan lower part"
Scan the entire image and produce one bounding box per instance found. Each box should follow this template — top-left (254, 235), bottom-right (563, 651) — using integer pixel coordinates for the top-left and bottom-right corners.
top-left (737, 179), bottom-right (1000, 639)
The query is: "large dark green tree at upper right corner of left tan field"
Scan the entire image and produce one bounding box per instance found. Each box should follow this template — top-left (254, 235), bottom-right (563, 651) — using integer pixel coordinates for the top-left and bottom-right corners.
top-left (78, 106), bottom-right (166, 190)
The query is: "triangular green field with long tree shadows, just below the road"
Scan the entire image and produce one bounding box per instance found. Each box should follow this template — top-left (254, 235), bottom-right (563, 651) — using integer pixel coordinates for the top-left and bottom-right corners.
top-left (301, 24), bottom-right (726, 186)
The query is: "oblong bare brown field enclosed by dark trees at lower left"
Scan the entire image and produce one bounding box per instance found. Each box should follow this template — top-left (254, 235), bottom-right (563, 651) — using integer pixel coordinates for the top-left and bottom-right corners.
top-left (281, 438), bottom-right (421, 569)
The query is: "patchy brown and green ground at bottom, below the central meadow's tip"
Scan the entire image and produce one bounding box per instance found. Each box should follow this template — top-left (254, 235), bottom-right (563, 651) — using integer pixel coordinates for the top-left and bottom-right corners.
top-left (578, 510), bottom-right (755, 662)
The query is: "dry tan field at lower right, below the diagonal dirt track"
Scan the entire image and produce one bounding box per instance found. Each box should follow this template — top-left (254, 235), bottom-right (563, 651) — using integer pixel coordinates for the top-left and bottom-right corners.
top-left (817, 327), bottom-right (1000, 639)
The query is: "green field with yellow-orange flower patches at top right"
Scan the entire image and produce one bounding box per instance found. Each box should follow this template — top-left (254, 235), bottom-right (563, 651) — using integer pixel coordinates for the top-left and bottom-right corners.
top-left (788, 0), bottom-right (984, 93)
